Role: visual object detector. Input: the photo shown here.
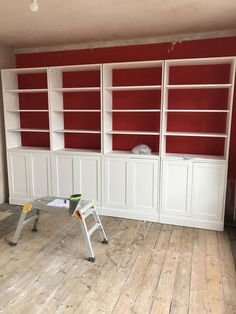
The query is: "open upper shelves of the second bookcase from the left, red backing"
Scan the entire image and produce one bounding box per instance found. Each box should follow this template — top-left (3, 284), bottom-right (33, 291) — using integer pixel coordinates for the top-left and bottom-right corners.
top-left (49, 64), bottom-right (102, 152)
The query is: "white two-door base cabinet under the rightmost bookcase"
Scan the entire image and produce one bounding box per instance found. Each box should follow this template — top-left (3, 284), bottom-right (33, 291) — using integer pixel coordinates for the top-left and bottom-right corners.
top-left (160, 159), bottom-right (226, 230)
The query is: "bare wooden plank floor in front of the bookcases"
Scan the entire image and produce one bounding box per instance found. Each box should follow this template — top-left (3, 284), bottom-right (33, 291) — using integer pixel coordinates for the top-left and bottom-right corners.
top-left (0, 209), bottom-right (236, 314)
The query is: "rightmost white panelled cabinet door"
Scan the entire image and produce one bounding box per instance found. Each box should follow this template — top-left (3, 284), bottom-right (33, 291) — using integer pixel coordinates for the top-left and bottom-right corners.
top-left (192, 162), bottom-right (226, 221)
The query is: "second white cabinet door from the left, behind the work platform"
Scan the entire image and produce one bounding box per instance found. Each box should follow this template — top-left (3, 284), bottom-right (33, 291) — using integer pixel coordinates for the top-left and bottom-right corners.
top-left (29, 153), bottom-right (51, 198)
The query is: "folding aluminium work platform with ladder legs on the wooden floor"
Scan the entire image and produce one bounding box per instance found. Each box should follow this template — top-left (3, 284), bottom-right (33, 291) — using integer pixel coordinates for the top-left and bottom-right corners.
top-left (9, 197), bottom-right (108, 262)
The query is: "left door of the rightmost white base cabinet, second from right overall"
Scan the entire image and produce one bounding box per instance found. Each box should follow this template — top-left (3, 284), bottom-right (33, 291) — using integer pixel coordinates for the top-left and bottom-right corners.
top-left (161, 160), bottom-right (192, 216)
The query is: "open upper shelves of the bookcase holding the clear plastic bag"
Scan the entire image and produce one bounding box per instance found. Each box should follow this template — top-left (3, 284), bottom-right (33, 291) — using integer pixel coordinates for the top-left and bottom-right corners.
top-left (103, 61), bottom-right (164, 155)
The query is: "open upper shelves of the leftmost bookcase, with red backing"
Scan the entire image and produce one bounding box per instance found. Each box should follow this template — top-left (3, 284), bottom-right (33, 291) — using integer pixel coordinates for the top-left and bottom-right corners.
top-left (2, 68), bottom-right (50, 149)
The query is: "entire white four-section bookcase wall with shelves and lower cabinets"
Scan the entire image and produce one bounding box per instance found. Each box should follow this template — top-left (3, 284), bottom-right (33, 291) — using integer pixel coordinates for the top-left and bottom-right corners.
top-left (2, 57), bottom-right (236, 230)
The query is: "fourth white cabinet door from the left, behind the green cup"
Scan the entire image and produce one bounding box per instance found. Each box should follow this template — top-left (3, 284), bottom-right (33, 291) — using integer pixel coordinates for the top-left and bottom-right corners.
top-left (74, 156), bottom-right (102, 206)
